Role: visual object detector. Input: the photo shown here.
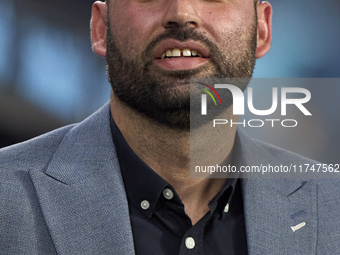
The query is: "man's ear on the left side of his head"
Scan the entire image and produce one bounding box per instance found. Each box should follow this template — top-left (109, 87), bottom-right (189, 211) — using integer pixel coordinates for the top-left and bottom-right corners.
top-left (91, 1), bottom-right (107, 57)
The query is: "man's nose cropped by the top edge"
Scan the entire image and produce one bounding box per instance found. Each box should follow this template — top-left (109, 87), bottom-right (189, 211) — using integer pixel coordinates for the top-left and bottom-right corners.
top-left (162, 0), bottom-right (200, 28)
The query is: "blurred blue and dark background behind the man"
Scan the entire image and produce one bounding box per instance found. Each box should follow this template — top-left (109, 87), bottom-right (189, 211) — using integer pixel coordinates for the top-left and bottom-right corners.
top-left (0, 0), bottom-right (340, 163)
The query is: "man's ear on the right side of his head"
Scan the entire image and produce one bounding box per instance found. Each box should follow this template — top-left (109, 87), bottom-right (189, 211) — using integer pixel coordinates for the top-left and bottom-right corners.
top-left (255, 2), bottom-right (273, 58)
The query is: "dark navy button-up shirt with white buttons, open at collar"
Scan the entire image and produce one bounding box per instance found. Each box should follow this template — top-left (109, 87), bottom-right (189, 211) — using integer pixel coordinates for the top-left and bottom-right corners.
top-left (111, 118), bottom-right (247, 255)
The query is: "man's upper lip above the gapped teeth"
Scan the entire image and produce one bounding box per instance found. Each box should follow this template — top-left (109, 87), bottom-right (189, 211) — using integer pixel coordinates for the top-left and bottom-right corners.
top-left (154, 39), bottom-right (209, 59)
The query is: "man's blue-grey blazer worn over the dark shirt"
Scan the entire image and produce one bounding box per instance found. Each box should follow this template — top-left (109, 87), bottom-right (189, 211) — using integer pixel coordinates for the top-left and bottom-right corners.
top-left (0, 104), bottom-right (340, 255)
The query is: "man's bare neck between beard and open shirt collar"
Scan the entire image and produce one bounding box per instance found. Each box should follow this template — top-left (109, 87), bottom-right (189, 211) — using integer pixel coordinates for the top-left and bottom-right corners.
top-left (111, 93), bottom-right (237, 224)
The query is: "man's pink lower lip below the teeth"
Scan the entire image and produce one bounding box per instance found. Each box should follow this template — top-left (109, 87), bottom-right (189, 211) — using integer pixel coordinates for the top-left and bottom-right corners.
top-left (155, 57), bottom-right (209, 71)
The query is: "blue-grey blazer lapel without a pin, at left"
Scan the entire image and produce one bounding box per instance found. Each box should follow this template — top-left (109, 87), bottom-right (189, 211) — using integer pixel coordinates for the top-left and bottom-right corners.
top-left (30, 105), bottom-right (134, 254)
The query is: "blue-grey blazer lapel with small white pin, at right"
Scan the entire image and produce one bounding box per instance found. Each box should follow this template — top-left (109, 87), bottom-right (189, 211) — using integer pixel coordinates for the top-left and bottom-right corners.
top-left (238, 129), bottom-right (317, 255)
